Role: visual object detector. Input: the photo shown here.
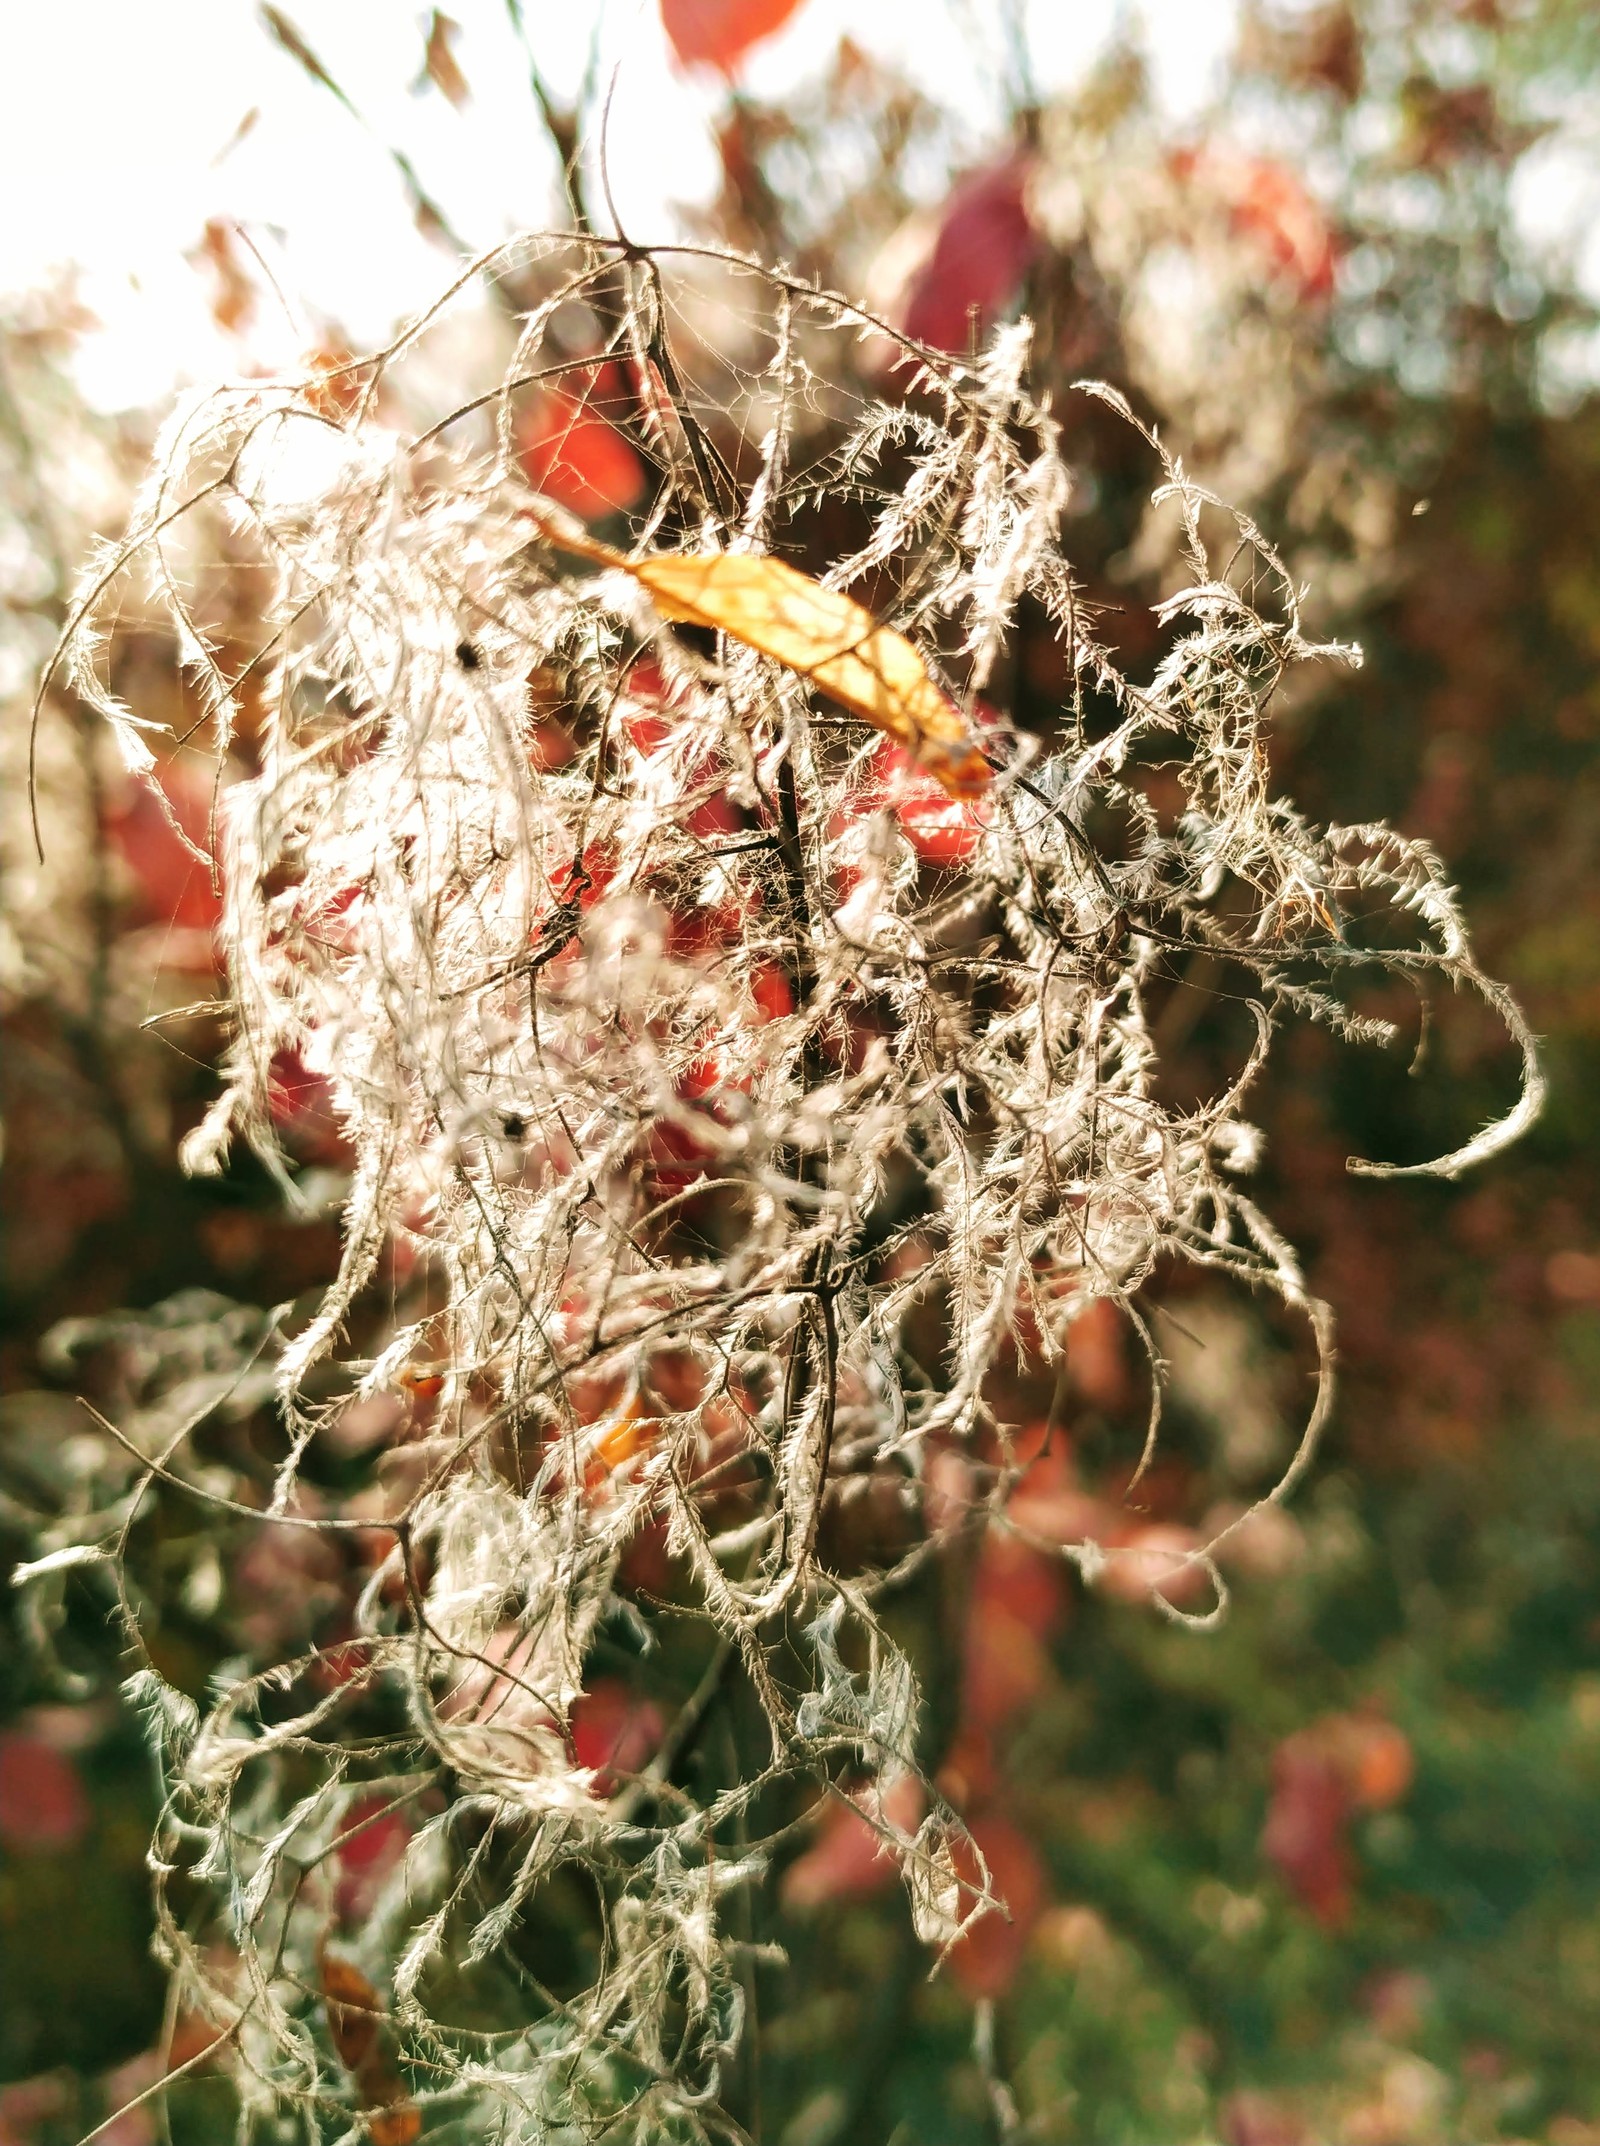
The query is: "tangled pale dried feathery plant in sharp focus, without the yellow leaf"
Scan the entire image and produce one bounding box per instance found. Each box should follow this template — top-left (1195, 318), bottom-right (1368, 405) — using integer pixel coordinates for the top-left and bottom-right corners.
top-left (34, 238), bottom-right (1540, 2140)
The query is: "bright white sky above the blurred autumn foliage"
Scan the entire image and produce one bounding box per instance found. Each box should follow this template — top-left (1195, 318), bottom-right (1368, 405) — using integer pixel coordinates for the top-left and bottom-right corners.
top-left (0, 0), bottom-right (1235, 408)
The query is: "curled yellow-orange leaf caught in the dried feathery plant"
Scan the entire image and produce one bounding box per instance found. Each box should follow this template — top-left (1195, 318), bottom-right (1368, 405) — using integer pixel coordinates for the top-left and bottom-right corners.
top-left (523, 513), bottom-right (991, 798)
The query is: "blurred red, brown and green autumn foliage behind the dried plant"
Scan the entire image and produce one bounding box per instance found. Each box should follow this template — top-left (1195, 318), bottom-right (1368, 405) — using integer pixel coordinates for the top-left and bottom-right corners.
top-left (0, 0), bottom-right (1600, 2146)
